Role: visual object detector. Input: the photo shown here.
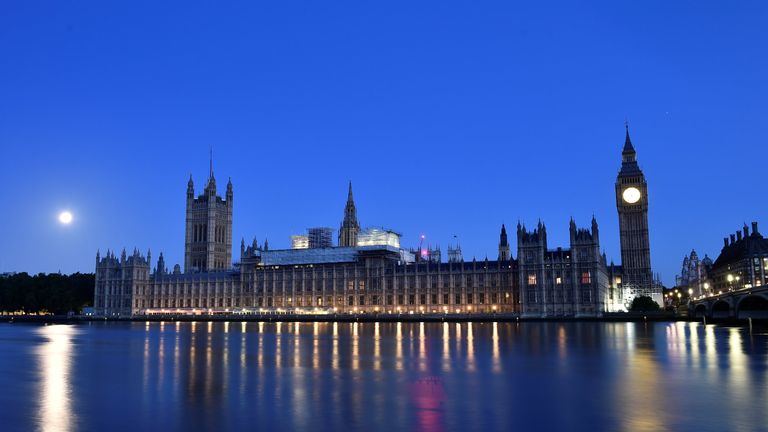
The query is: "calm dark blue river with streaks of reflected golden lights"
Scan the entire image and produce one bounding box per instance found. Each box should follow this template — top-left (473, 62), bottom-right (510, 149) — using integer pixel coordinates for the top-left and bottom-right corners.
top-left (0, 322), bottom-right (768, 431)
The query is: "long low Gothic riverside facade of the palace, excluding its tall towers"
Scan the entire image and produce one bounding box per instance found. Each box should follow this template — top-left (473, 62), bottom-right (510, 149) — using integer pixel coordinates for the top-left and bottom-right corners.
top-left (96, 226), bottom-right (607, 317)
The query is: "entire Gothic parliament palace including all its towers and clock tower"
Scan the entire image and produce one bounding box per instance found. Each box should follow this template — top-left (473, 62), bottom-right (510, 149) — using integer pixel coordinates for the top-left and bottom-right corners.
top-left (94, 128), bottom-right (661, 318)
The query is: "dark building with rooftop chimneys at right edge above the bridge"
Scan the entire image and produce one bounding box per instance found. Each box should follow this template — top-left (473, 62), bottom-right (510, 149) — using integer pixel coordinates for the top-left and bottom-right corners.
top-left (708, 222), bottom-right (768, 294)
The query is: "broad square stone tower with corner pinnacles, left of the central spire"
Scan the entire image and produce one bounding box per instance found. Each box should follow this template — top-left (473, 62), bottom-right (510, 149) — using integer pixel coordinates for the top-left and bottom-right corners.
top-left (184, 158), bottom-right (233, 273)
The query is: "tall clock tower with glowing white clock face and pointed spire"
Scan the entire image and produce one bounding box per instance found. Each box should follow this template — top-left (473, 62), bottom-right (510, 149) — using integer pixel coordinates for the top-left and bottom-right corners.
top-left (616, 126), bottom-right (661, 304)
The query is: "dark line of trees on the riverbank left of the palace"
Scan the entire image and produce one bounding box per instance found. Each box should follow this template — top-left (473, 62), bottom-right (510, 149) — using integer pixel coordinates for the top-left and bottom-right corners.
top-left (0, 273), bottom-right (95, 315)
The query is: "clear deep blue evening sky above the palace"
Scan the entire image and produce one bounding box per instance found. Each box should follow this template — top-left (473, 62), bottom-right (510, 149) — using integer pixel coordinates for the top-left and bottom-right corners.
top-left (0, 0), bottom-right (768, 284)
